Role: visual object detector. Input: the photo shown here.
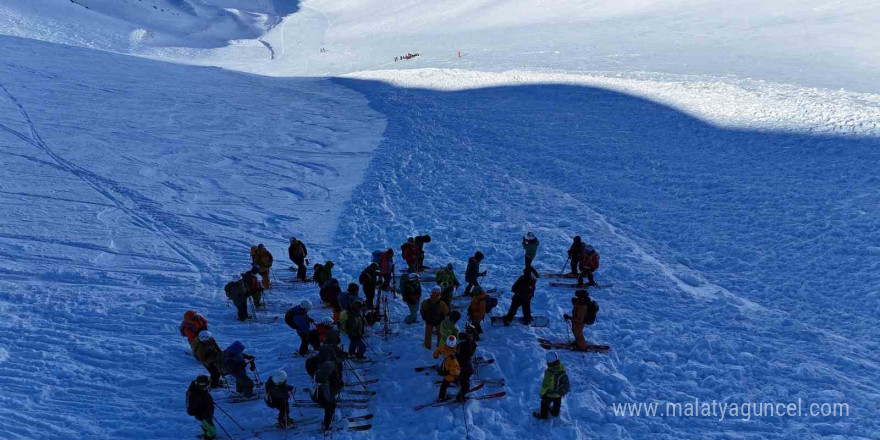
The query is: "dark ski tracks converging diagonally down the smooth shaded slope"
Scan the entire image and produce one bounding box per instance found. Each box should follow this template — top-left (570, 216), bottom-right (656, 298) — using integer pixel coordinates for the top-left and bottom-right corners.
top-left (0, 83), bottom-right (205, 277)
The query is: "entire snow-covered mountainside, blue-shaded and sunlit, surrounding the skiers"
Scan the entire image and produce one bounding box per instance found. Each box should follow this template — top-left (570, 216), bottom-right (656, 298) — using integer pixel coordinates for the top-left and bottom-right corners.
top-left (0, 0), bottom-right (880, 440)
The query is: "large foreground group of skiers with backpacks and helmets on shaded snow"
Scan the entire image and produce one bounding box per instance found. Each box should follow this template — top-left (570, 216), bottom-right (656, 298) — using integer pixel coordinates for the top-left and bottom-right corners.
top-left (180, 230), bottom-right (599, 440)
